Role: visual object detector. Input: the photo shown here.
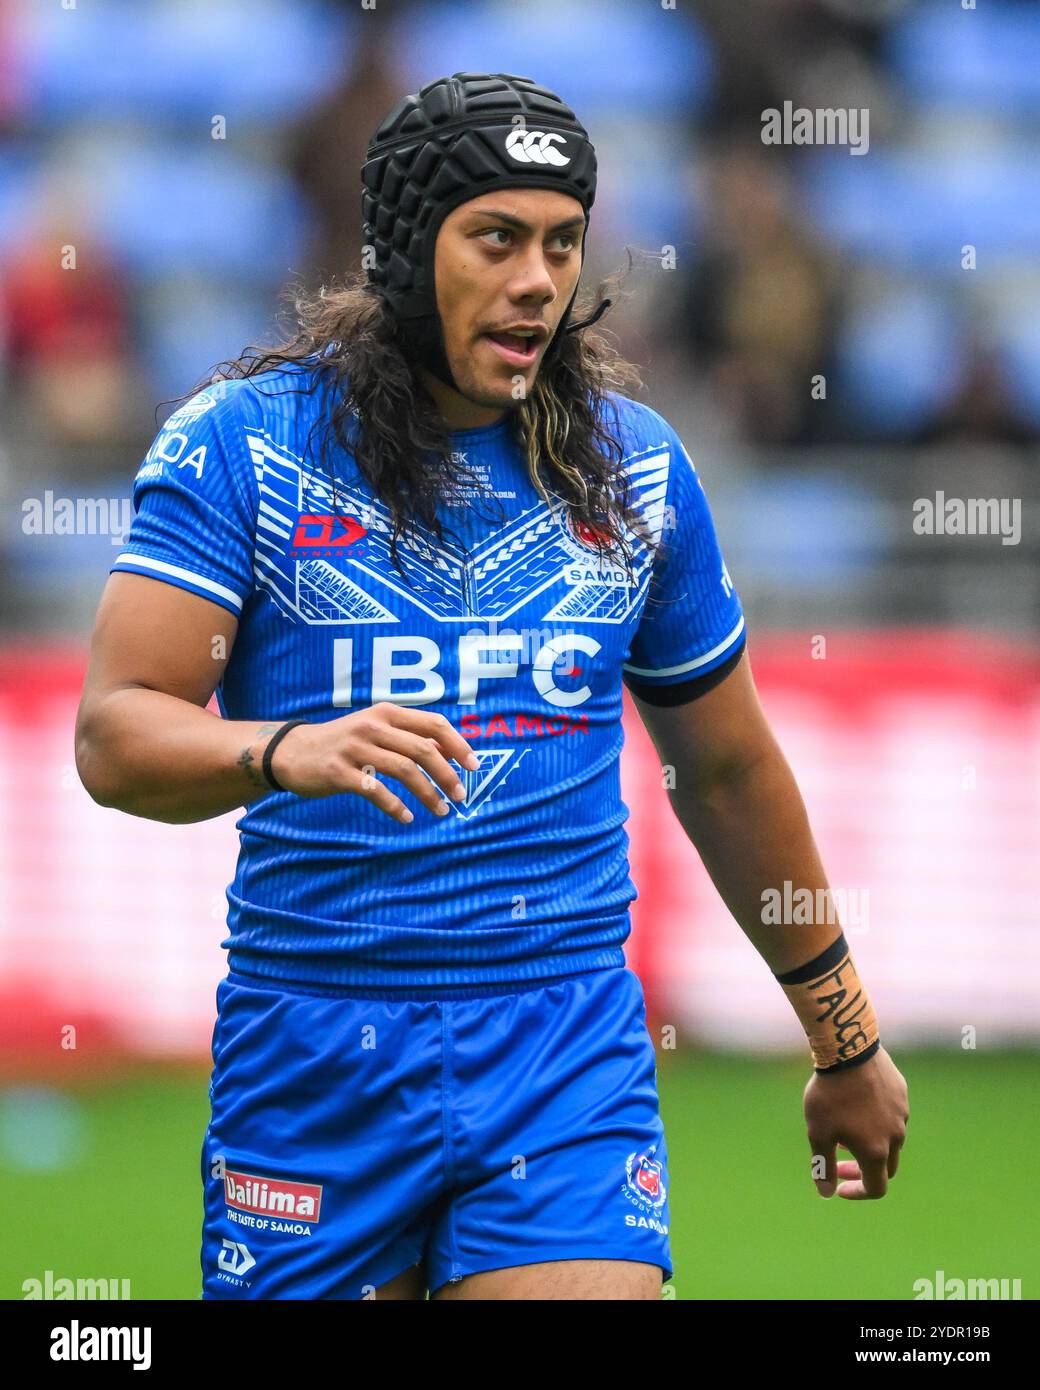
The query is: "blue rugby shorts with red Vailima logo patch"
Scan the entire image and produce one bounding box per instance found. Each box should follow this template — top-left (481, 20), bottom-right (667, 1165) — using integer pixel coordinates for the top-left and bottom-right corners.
top-left (202, 966), bottom-right (672, 1298)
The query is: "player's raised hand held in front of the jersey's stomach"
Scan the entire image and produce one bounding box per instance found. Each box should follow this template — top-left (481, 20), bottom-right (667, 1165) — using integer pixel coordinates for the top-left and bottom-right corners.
top-left (261, 701), bottom-right (478, 824)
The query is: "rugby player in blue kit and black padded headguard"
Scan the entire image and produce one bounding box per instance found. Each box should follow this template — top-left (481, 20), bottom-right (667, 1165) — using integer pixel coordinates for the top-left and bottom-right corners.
top-left (76, 72), bottom-right (907, 1300)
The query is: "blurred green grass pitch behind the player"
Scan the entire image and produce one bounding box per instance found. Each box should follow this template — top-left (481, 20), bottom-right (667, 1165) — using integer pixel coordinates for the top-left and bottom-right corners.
top-left (0, 1049), bottom-right (1040, 1300)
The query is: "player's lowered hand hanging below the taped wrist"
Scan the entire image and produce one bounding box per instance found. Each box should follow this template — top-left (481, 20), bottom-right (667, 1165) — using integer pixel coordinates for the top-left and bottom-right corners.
top-left (804, 1047), bottom-right (909, 1201)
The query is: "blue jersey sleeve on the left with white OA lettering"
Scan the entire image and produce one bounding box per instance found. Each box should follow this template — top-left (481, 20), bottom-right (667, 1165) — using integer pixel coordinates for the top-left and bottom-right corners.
top-left (110, 381), bottom-right (261, 614)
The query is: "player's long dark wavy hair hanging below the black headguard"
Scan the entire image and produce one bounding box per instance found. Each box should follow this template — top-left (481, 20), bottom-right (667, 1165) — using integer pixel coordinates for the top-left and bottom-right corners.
top-left (176, 254), bottom-right (653, 575)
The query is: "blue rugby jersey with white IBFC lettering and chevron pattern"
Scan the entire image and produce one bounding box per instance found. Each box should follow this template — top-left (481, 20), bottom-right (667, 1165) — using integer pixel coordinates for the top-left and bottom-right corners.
top-left (111, 368), bottom-right (744, 992)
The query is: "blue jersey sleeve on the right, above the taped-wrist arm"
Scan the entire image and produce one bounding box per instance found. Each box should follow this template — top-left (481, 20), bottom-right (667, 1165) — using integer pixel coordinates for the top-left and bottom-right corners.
top-left (621, 411), bottom-right (747, 705)
